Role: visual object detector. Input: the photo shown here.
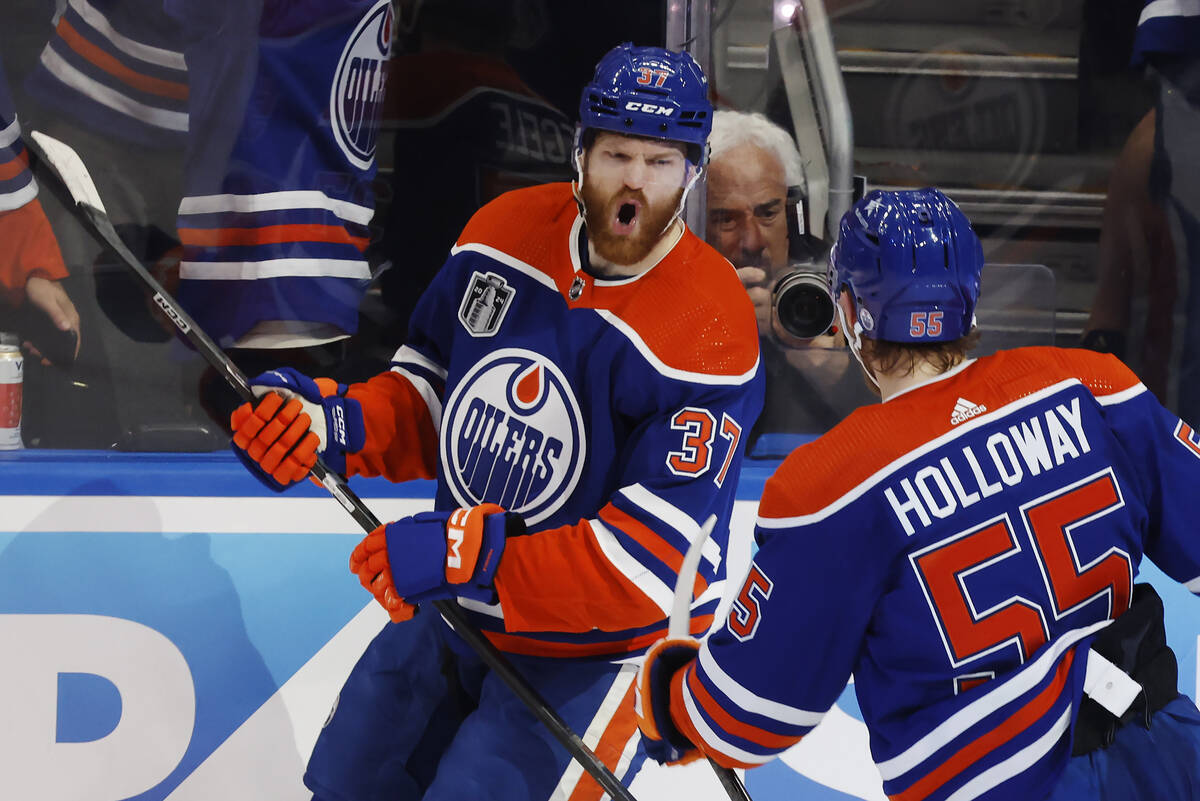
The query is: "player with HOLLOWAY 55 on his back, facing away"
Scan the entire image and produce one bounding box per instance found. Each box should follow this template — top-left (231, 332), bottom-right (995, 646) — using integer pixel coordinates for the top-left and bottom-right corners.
top-left (638, 189), bottom-right (1200, 801)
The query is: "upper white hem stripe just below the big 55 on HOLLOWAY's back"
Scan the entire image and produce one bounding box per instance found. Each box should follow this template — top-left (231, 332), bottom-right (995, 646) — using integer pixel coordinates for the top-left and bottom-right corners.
top-left (876, 620), bottom-right (1111, 782)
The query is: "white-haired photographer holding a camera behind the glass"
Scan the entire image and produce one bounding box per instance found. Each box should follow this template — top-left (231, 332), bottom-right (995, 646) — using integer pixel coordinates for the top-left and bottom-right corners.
top-left (706, 109), bottom-right (874, 456)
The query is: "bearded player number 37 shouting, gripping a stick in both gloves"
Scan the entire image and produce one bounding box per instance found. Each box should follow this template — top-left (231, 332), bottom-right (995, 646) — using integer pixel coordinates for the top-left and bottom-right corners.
top-left (233, 44), bottom-right (762, 801)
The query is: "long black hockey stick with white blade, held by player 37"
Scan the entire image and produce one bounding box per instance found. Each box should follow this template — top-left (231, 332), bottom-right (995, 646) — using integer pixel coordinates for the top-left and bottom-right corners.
top-left (24, 131), bottom-right (636, 801)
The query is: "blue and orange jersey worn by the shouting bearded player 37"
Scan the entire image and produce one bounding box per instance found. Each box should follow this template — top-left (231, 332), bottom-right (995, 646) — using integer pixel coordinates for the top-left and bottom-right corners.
top-left (347, 183), bottom-right (762, 657)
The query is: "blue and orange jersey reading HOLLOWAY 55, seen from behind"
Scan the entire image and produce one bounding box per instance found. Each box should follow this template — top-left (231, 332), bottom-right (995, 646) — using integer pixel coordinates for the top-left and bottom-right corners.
top-left (671, 348), bottom-right (1200, 801)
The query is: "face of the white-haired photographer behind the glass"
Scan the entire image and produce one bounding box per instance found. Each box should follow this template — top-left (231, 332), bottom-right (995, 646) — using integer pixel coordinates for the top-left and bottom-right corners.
top-left (704, 144), bottom-right (787, 275)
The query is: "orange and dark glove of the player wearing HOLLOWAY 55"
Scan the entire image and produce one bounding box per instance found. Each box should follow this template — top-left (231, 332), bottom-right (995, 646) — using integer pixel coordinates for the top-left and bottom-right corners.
top-left (635, 637), bottom-right (701, 765)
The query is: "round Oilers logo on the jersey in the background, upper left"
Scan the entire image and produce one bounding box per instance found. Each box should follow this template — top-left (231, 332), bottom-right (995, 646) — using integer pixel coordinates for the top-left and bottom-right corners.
top-left (329, 0), bottom-right (392, 169)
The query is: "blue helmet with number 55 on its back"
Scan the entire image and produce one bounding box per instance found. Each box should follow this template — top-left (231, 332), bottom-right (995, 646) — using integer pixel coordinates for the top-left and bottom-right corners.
top-left (829, 188), bottom-right (983, 344)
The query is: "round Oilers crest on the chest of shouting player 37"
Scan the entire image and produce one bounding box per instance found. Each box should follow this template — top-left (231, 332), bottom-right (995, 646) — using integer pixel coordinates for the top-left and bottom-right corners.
top-left (442, 348), bottom-right (587, 524)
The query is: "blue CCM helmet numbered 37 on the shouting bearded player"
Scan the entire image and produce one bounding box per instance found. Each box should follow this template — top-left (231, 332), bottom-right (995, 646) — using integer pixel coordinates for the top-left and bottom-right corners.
top-left (580, 42), bottom-right (713, 164)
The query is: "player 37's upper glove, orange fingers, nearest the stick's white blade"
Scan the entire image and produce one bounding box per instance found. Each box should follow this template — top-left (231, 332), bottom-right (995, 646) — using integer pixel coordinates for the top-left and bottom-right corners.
top-left (229, 367), bottom-right (366, 492)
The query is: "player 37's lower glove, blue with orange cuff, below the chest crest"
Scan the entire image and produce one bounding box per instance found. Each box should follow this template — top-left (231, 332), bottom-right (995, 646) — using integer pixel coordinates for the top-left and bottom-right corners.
top-left (350, 504), bottom-right (524, 612)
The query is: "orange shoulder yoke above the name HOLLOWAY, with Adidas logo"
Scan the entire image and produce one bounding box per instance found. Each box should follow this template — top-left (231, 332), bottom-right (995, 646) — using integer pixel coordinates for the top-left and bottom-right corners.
top-left (758, 348), bottom-right (1140, 518)
